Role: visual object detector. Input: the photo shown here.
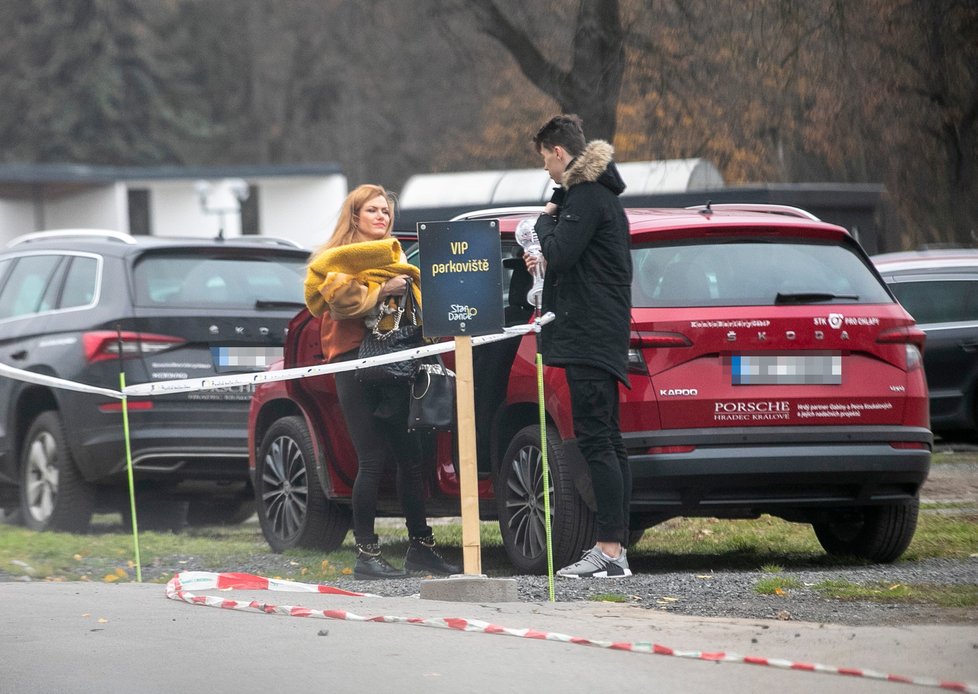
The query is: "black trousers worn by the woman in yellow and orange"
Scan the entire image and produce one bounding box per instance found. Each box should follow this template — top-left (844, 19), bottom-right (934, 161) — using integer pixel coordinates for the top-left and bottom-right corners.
top-left (334, 351), bottom-right (431, 544)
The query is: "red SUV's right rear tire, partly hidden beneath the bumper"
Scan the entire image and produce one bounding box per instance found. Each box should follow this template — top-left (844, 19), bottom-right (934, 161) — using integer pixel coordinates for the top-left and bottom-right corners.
top-left (812, 499), bottom-right (920, 564)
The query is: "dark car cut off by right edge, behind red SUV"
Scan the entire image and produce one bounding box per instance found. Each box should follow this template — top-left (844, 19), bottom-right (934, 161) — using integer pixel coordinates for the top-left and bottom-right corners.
top-left (872, 248), bottom-right (978, 436)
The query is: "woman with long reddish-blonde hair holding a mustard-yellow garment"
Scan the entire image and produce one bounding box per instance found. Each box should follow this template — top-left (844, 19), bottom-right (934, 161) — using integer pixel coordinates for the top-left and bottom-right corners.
top-left (306, 185), bottom-right (461, 579)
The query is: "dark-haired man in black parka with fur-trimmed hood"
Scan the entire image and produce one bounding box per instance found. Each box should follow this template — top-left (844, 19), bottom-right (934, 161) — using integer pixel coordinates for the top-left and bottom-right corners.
top-left (526, 115), bottom-right (632, 578)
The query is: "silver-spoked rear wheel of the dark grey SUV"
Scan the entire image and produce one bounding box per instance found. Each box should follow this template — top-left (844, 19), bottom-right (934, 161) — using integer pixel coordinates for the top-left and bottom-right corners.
top-left (20, 411), bottom-right (95, 534)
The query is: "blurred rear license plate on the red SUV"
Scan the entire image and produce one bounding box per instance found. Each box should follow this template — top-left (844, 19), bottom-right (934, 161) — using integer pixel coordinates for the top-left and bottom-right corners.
top-left (731, 354), bottom-right (842, 386)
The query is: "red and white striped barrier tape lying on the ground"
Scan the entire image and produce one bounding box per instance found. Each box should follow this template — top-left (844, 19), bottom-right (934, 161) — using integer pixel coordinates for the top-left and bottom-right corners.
top-left (166, 571), bottom-right (978, 694)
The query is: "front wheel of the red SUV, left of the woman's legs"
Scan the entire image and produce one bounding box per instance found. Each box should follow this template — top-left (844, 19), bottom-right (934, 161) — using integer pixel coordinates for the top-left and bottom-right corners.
top-left (255, 417), bottom-right (350, 552)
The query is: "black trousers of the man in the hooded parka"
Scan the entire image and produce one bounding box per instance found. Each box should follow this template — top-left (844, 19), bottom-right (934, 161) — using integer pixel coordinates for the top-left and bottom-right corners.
top-left (564, 364), bottom-right (632, 546)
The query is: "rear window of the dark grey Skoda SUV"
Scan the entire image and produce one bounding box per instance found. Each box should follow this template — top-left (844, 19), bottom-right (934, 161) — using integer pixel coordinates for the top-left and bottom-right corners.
top-left (133, 254), bottom-right (306, 308)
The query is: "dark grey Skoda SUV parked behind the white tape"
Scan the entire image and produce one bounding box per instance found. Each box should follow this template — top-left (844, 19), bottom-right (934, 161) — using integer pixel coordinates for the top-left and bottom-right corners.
top-left (0, 230), bottom-right (308, 532)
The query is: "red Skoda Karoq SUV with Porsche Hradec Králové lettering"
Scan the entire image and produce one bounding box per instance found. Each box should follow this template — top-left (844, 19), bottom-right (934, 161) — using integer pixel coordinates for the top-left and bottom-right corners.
top-left (249, 205), bottom-right (933, 573)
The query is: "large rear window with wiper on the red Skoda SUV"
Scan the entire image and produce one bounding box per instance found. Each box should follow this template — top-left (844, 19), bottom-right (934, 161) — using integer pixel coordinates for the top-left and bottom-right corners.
top-left (632, 238), bottom-right (893, 307)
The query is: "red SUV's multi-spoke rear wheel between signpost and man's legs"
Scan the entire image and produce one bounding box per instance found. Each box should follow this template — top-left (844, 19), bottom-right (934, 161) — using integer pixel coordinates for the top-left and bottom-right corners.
top-left (495, 425), bottom-right (595, 574)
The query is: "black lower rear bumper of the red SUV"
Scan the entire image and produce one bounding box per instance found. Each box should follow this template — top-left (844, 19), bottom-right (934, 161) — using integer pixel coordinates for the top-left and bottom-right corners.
top-left (623, 427), bottom-right (933, 518)
